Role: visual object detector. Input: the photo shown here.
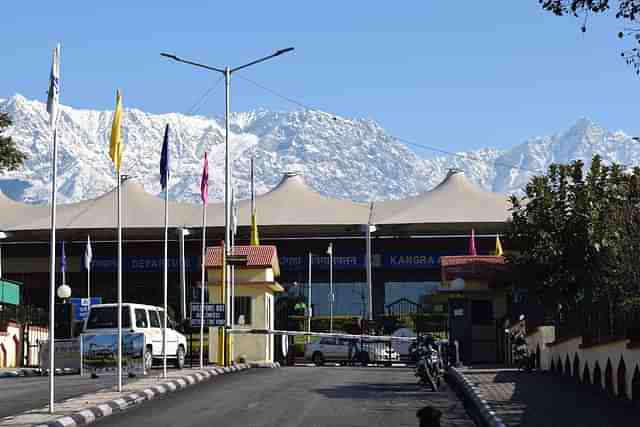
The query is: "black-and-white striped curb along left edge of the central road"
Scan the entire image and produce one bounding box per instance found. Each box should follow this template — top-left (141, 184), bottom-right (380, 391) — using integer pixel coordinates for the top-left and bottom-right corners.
top-left (34, 363), bottom-right (280, 427)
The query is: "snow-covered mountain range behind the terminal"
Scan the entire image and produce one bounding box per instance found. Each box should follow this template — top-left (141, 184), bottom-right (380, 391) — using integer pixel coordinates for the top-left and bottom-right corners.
top-left (0, 95), bottom-right (640, 202)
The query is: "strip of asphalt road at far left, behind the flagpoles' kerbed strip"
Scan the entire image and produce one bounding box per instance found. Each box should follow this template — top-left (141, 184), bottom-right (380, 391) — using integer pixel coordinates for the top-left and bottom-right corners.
top-left (0, 368), bottom-right (180, 418)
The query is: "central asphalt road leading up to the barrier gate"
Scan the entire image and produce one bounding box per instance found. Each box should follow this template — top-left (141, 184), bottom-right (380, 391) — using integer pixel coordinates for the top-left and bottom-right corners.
top-left (97, 367), bottom-right (475, 427)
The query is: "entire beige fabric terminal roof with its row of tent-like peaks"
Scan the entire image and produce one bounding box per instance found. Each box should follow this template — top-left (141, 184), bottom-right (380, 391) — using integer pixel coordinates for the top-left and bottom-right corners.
top-left (0, 172), bottom-right (510, 231)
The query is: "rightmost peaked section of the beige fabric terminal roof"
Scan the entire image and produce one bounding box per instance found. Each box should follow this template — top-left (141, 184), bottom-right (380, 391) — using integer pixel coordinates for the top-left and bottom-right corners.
top-left (373, 171), bottom-right (510, 225)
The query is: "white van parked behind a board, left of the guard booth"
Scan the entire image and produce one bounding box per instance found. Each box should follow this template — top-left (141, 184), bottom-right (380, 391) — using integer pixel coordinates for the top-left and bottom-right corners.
top-left (83, 303), bottom-right (187, 369)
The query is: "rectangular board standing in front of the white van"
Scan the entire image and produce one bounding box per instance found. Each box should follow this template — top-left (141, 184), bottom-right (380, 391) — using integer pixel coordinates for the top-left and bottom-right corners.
top-left (80, 333), bottom-right (144, 375)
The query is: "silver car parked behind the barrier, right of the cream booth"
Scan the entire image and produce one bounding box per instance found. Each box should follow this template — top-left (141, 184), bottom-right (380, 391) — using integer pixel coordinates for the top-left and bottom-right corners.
top-left (304, 337), bottom-right (400, 366)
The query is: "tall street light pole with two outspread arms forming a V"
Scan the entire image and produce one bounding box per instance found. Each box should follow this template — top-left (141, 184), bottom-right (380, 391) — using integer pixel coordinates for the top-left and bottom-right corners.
top-left (160, 47), bottom-right (294, 365)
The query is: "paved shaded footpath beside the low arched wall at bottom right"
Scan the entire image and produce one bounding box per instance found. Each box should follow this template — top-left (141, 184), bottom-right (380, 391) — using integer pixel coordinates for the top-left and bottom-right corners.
top-left (459, 368), bottom-right (640, 427)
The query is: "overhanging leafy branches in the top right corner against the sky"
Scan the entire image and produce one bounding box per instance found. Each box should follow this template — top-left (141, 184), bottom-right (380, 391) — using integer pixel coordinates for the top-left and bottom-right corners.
top-left (538, 0), bottom-right (640, 75)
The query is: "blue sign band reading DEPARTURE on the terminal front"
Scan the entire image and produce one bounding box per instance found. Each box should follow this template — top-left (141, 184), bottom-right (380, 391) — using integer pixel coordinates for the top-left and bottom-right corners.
top-left (91, 256), bottom-right (200, 273)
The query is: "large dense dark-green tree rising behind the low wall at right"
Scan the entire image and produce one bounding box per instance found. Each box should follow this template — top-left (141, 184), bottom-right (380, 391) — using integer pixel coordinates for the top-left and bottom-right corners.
top-left (508, 156), bottom-right (640, 330)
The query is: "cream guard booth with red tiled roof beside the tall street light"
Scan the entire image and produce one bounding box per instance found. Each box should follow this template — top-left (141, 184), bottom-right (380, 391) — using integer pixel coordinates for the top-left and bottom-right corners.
top-left (205, 245), bottom-right (284, 362)
